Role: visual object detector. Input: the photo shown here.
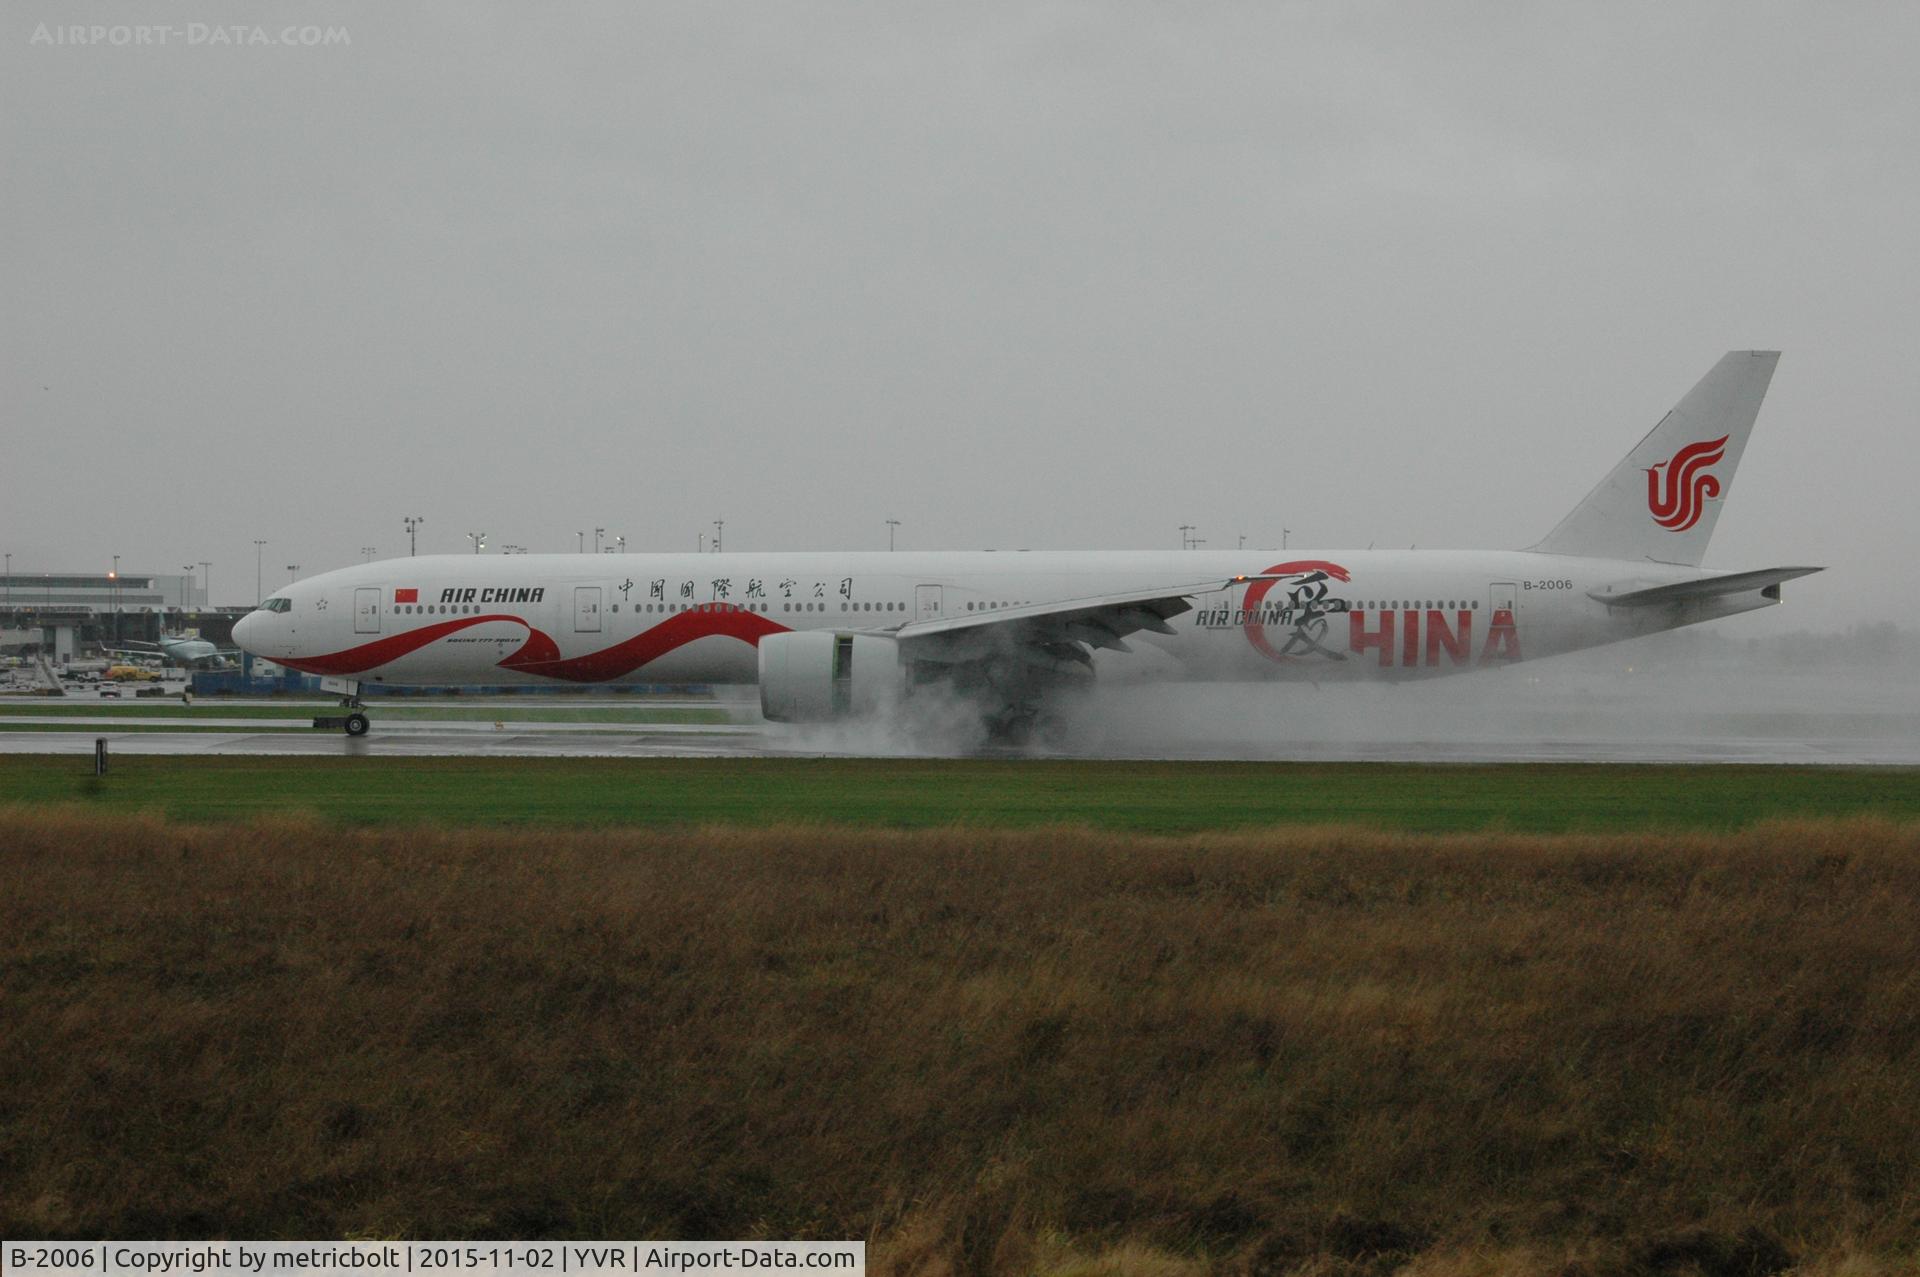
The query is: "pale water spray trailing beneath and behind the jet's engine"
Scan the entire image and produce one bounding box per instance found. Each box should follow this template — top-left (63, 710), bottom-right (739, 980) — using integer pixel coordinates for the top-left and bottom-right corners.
top-left (766, 624), bottom-right (1920, 764)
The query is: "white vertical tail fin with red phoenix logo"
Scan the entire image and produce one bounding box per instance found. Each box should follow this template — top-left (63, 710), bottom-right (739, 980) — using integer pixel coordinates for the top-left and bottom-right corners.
top-left (1530, 349), bottom-right (1780, 566)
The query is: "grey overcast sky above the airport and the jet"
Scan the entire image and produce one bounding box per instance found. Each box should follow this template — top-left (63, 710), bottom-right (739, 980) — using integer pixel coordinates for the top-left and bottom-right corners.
top-left (0, 0), bottom-right (1920, 632)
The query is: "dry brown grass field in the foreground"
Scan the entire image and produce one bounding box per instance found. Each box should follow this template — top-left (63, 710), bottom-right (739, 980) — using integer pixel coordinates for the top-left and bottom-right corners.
top-left (0, 807), bottom-right (1920, 1275)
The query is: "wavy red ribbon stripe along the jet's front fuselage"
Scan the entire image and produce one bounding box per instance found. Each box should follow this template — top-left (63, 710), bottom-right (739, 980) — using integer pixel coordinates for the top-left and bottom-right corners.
top-left (276, 609), bottom-right (787, 684)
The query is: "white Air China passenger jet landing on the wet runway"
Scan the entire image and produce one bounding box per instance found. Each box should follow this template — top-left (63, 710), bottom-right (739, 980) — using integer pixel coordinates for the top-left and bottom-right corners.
top-left (234, 351), bottom-right (1818, 735)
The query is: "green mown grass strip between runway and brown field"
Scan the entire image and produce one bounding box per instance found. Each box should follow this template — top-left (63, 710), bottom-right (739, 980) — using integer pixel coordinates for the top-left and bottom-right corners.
top-left (0, 755), bottom-right (1920, 833)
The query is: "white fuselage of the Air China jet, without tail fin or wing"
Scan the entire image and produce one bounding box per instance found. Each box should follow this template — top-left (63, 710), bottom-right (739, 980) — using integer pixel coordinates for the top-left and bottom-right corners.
top-left (234, 551), bottom-right (1772, 686)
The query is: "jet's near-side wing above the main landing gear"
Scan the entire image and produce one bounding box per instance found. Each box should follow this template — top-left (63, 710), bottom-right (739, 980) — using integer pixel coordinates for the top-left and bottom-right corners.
top-left (887, 576), bottom-right (1250, 666)
